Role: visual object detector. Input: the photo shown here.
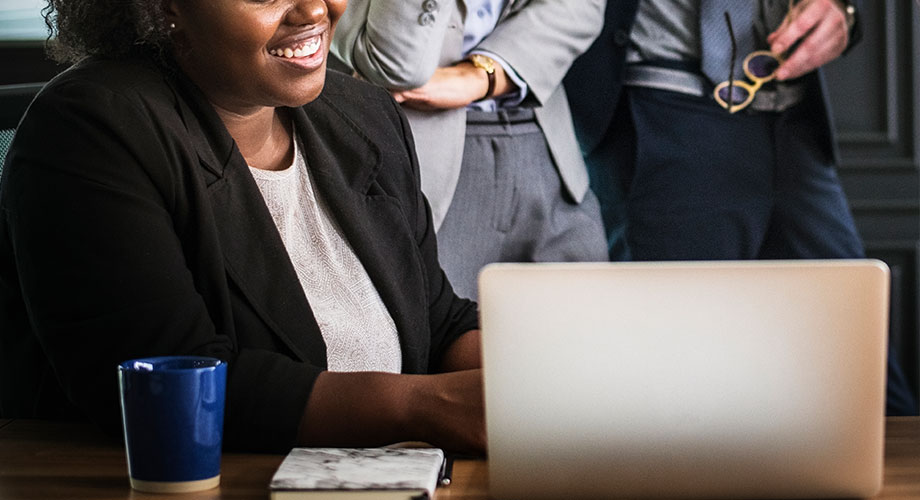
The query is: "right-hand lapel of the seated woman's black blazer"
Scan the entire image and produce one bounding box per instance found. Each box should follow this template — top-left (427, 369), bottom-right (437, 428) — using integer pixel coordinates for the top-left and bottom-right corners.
top-left (294, 96), bottom-right (428, 372)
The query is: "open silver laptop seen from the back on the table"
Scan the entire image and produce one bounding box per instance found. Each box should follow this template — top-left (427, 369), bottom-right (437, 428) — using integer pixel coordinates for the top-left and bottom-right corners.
top-left (479, 260), bottom-right (889, 500)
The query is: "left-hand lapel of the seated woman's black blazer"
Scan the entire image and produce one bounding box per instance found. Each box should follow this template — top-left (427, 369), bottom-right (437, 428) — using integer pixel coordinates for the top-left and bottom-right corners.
top-left (172, 78), bottom-right (326, 367)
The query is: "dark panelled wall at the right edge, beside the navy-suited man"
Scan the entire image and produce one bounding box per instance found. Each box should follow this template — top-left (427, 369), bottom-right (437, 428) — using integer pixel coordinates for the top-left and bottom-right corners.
top-left (827, 0), bottom-right (920, 406)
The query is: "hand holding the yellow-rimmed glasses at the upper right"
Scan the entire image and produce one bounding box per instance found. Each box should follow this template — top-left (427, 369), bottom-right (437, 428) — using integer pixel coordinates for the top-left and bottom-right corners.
top-left (767, 0), bottom-right (850, 80)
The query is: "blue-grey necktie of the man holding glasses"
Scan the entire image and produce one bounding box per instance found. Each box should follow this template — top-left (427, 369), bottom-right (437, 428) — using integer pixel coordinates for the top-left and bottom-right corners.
top-left (700, 0), bottom-right (760, 85)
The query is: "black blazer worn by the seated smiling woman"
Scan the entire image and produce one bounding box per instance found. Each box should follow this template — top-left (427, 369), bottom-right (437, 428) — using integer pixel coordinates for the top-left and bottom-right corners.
top-left (0, 58), bottom-right (477, 451)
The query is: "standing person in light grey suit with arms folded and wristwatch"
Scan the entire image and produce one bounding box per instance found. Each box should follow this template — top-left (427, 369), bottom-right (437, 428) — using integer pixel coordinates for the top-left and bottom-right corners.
top-left (332, 0), bottom-right (607, 298)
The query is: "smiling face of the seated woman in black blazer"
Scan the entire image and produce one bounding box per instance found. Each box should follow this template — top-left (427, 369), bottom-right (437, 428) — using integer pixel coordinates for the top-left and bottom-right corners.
top-left (168, 0), bottom-right (347, 114)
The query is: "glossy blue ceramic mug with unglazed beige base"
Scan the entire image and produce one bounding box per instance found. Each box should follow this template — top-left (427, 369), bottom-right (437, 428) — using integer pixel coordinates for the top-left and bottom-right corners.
top-left (118, 356), bottom-right (227, 493)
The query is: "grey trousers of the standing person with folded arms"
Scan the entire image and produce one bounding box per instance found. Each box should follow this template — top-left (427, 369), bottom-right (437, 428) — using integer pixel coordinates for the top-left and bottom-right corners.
top-left (438, 109), bottom-right (607, 300)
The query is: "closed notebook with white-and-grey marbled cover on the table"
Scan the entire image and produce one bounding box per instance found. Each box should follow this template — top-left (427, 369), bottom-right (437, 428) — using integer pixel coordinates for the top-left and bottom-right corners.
top-left (269, 448), bottom-right (445, 500)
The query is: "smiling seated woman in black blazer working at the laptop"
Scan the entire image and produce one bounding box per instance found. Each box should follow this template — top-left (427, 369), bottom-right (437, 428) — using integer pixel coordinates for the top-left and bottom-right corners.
top-left (0, 0), bottom-right (485, 452)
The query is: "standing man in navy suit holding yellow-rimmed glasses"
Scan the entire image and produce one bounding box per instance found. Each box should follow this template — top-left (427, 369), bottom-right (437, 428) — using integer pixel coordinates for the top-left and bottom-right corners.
top-left (565, 0), bottom-right (916, 414)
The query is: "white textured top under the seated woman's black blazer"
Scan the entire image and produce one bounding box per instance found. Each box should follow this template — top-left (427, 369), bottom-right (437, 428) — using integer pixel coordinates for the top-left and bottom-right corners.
top-left (249, 131), bottom-right (402, 373)
